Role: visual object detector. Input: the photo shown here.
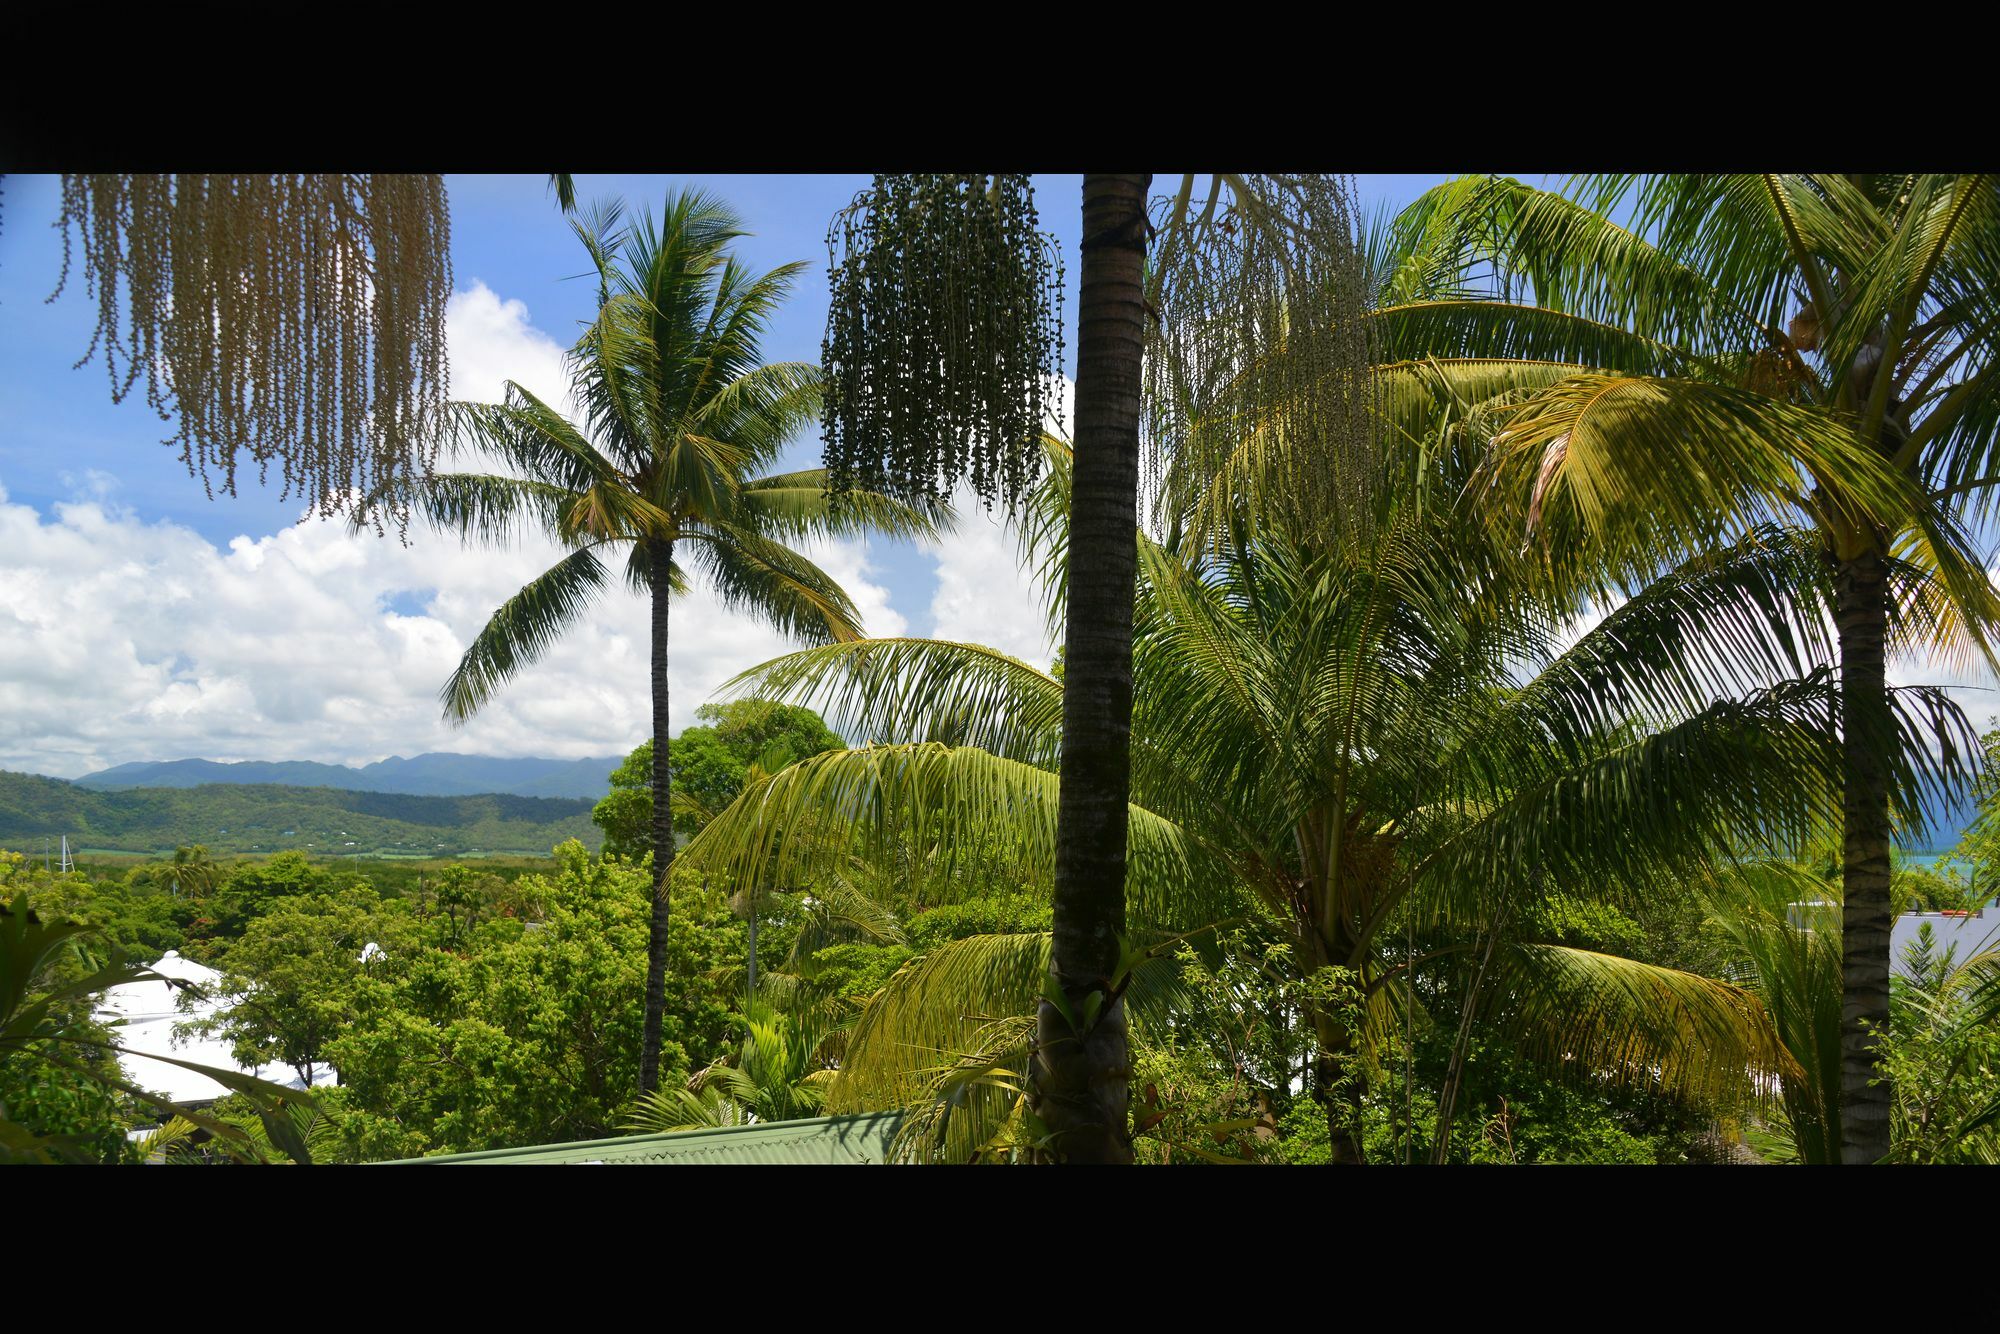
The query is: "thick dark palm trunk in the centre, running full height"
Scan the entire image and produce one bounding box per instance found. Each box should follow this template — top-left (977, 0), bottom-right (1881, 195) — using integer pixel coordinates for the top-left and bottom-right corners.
top-left (1028, 174), bottom-right (1152, 1164)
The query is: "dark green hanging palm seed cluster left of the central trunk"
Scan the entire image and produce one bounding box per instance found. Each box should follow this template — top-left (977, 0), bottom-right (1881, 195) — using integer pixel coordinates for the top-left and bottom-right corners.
top-left (820, 176), bottom-right (1062, 512)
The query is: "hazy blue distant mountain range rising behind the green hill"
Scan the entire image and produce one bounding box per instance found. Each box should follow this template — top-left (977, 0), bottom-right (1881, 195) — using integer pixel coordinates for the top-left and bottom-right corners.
top-left (76, 752), bottom-right (624, 802)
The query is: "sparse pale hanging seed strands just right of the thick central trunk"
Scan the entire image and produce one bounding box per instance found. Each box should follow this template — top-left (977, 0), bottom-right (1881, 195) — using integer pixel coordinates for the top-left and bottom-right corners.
top-left (1144, 174), bottom-right (1380, 534)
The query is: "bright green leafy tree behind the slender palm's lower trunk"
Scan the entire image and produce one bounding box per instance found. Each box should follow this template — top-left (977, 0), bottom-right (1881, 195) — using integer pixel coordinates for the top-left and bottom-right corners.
top-left (326, 842), bottom-right (744, 1158)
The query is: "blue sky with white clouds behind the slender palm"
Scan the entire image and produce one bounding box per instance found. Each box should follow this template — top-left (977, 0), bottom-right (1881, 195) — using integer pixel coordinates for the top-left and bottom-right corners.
top-left (0, 176), bottom-right (1472, 776)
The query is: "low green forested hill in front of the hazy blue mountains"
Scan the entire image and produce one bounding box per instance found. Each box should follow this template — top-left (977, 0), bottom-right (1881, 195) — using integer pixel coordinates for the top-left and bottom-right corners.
top-left (0, 772), bottom-right (602, 854)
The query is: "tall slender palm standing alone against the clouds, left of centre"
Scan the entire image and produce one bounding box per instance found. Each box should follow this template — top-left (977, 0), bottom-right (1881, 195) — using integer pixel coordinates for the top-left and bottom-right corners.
top-left (402, 190), bottom-right (948, 1092)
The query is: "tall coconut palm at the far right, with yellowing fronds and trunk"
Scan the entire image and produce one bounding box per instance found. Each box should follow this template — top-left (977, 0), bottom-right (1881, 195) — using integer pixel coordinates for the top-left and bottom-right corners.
top-left (1374, 174), bottom-right (2000, 1162)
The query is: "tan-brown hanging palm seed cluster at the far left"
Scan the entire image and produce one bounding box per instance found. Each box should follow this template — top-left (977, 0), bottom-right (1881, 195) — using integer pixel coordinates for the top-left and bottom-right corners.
top-left (50, 174), bottom-right (452, 528)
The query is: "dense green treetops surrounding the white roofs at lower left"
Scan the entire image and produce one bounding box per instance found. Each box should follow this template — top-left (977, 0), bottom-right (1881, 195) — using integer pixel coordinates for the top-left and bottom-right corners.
top-left (0, 840), bottom-right (768, 1160)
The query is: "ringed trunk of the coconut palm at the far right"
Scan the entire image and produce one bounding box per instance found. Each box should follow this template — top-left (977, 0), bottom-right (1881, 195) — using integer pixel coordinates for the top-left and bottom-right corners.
top-left (1834, 542), bottom-right (1894, 1162)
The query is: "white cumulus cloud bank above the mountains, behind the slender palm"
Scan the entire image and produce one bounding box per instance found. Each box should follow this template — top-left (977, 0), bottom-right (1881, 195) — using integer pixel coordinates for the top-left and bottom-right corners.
top-left (0, 286), bottom-right (906, 776)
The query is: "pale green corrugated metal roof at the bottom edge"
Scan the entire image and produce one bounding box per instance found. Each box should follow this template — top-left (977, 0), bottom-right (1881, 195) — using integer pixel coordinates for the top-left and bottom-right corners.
top-left (380, 1112), bottom-right (902, 1168)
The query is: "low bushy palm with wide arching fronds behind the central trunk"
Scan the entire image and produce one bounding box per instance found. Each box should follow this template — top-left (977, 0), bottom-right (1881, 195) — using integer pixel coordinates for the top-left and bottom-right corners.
top-left (688, 410), bottom-right (1960, 1162)
